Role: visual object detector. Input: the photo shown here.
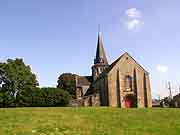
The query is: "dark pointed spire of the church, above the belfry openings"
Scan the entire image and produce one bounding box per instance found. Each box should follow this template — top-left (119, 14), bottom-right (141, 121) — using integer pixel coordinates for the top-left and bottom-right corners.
top-left (94, 32), bottom-right (108, 65)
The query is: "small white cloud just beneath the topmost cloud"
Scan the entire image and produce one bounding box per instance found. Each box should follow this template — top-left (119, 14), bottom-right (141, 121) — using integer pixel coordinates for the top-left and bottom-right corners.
top-left (127, 19), bottom-right (142, 30)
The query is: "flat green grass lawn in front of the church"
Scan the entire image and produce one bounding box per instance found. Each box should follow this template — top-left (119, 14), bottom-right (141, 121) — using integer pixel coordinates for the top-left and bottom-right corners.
top-left (0, 108), bottom-right (180, 135)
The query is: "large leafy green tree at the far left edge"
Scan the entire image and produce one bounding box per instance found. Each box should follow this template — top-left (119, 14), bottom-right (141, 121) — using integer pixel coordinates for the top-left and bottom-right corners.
top-left (0, 58), bottom-right (38, 107)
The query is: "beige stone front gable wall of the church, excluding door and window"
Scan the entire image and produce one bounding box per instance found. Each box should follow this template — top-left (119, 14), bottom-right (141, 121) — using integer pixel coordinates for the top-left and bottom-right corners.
top-left (108, 54), bottom-right (152, 108)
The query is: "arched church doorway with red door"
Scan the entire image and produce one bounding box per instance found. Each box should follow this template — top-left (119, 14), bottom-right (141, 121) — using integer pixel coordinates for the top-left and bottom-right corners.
top-left (124, 94), bottom-right (136, 108)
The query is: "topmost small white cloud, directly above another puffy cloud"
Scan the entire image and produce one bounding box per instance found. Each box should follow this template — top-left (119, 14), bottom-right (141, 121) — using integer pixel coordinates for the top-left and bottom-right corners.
top-left (126, 8), bottom-right (142, 19)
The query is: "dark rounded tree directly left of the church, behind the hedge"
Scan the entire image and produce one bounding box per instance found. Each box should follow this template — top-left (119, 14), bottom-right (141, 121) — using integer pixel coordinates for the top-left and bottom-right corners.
top-left (57, 73), bottom-right (76, 98)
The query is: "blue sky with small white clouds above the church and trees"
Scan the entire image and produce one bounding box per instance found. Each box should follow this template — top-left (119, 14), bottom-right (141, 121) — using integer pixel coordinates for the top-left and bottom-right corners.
top-left (0, 0), bottom-right (180, 97)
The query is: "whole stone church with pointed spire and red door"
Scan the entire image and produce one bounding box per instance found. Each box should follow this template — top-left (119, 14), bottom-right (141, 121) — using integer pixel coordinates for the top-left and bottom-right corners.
top-left (75, 33), bottom-right (152, 108)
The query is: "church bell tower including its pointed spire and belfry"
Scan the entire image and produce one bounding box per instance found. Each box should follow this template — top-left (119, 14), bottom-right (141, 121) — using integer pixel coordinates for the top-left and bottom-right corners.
top-left (92, 32), bottom-right (108, 81)
